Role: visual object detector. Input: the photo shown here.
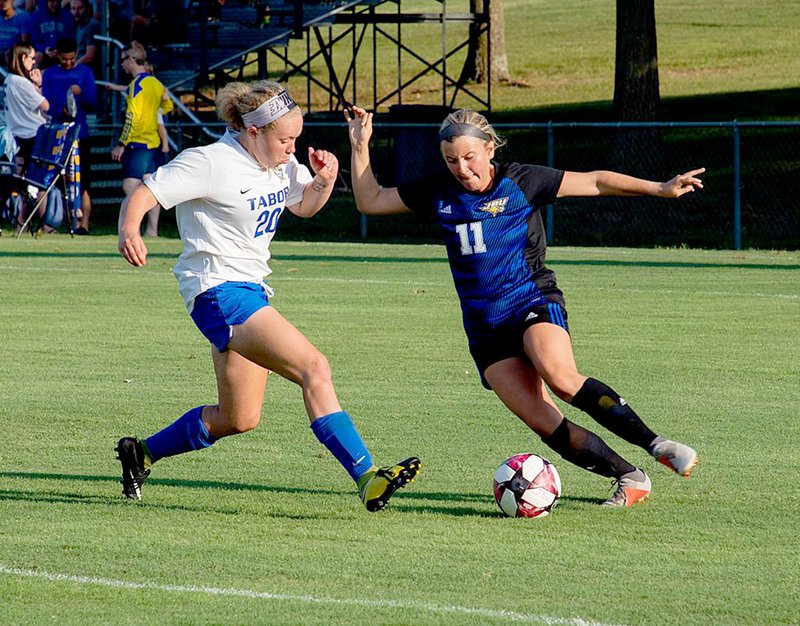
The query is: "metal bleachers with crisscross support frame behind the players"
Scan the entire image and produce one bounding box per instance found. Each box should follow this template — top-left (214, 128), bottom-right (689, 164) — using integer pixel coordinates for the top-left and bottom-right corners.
top-left (144, 0), bottom-right (491, 111)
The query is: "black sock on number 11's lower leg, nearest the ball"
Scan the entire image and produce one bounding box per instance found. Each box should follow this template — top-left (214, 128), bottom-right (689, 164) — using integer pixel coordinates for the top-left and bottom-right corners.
top-left (542, 418), bottom-right (636, 478)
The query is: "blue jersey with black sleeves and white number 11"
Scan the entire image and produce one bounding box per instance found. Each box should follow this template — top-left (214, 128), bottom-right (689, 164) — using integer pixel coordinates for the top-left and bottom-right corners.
top-left (398, 163), bottom-right (564, 332)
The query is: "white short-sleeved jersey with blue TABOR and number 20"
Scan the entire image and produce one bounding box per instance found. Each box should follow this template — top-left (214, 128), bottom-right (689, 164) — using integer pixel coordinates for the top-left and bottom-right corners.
top-left (145, 132), bottom-right (312, 312)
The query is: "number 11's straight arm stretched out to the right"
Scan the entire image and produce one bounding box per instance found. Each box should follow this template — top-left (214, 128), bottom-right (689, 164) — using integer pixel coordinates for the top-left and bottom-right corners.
top-left (558, 168), bottom-right (706, 198)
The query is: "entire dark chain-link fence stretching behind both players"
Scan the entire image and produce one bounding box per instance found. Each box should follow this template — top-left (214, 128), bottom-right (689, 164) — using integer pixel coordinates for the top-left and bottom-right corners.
top-left (164, 116), bottom-right (800, 249)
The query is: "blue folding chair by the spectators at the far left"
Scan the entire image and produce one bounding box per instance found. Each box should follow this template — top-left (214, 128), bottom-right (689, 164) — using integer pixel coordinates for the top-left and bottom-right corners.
top-left (0, 122), bottom-right (81, 238)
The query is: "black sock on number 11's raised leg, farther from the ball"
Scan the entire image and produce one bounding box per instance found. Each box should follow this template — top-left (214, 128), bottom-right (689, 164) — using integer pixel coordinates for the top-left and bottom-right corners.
top-left (571, 378), bottom-right (656, 450)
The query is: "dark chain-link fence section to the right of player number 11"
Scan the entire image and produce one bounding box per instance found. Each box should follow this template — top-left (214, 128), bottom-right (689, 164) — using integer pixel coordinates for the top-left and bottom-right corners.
top-left (496, 122), bottom-right (800, 249)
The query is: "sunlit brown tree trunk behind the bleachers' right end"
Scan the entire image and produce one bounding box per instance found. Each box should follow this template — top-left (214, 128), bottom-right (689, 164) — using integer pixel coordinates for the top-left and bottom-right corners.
top-left (459, 0), bottom-right (511, 83)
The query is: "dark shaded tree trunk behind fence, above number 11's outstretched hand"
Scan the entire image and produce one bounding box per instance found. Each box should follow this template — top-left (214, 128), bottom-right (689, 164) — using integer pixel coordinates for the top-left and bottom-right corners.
top-left (614, 0), bottom-right (660, 122)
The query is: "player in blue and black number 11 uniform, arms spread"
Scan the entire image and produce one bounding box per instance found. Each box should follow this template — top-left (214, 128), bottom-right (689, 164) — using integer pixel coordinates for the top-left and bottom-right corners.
top-left (345, 107), bottom-right (705, 506)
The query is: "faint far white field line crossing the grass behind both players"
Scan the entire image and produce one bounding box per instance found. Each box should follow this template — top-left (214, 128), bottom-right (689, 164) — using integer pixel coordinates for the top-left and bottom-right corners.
top-left (0, 265), bottom-right (800, 300)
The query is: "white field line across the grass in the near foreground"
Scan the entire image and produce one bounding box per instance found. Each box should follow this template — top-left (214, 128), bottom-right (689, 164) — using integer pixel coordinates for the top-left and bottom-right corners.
top-left (0, 564), bottom-right (624, 626)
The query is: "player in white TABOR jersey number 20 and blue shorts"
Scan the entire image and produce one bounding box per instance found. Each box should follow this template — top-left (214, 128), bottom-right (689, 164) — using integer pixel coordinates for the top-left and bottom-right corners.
top-left (116, 81), bottom-right (420, 511)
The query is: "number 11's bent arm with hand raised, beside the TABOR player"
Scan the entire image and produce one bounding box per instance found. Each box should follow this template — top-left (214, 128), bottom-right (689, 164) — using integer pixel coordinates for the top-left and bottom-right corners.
top-left (344, 105), bottom-right (409, 215)
